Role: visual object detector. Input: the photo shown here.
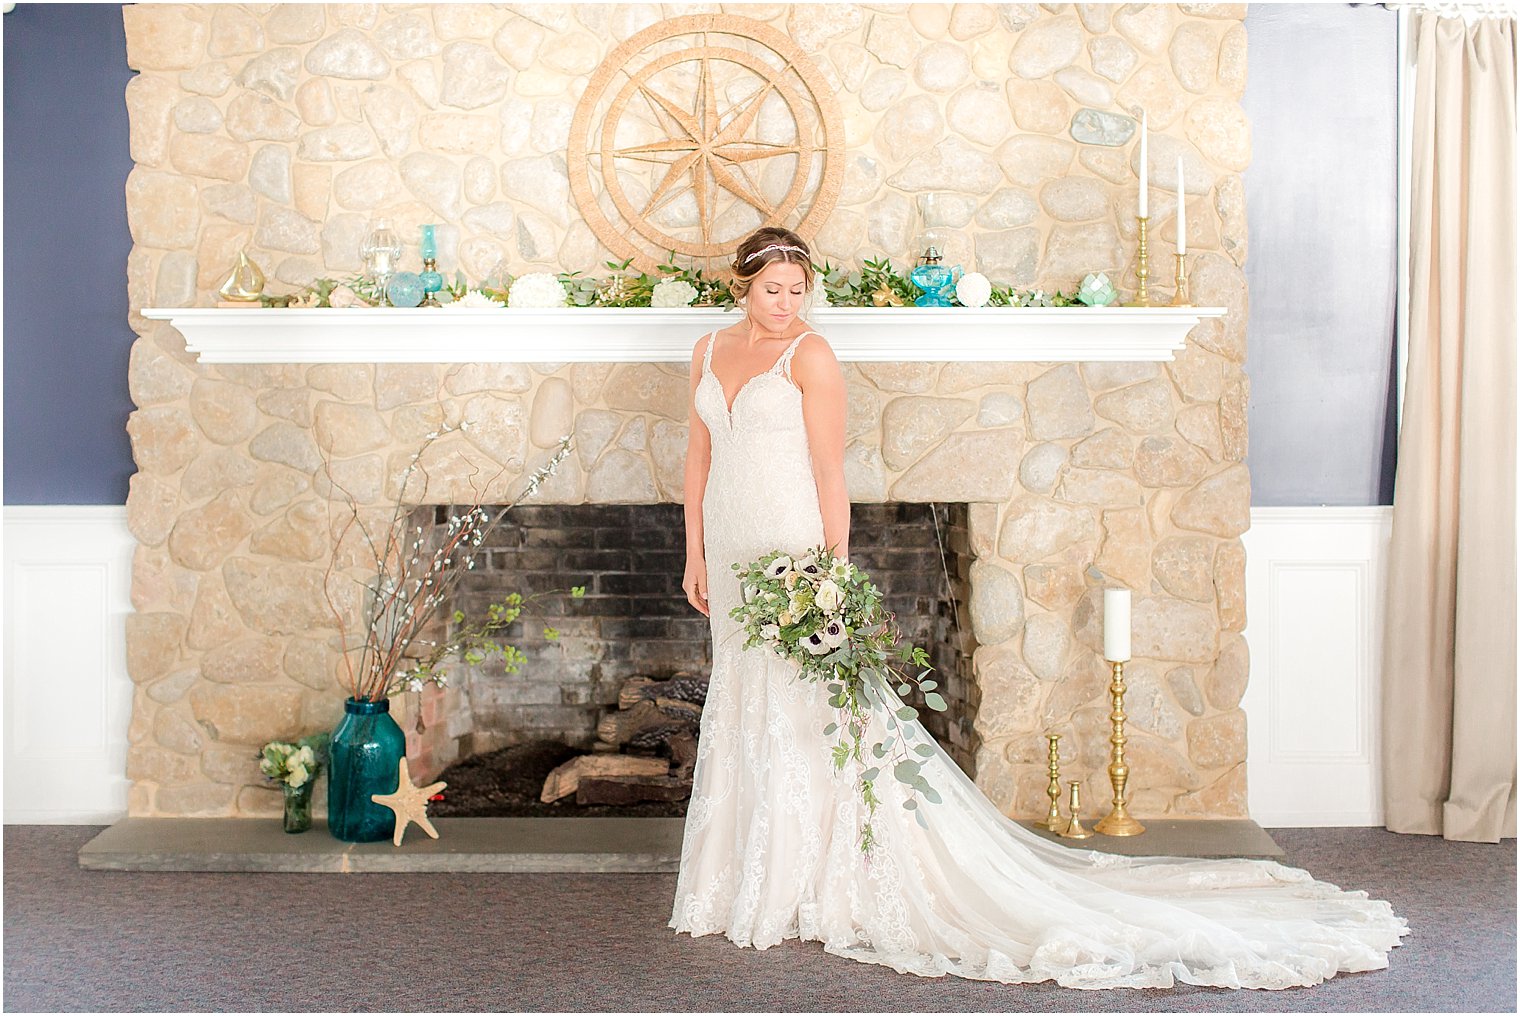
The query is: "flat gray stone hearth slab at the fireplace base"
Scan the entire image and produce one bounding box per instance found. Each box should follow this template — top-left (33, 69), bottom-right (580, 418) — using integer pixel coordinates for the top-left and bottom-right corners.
top-left (79, 818), bottom-right (1284, 873)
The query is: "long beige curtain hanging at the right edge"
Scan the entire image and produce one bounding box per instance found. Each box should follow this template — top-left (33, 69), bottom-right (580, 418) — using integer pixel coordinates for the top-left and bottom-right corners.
top-left (1383, 14), bottom-right (1515, 843)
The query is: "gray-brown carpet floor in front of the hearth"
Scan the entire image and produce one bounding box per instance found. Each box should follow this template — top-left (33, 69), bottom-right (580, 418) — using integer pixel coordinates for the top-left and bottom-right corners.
top-left (3, 826), bottom-right (1515, 1013)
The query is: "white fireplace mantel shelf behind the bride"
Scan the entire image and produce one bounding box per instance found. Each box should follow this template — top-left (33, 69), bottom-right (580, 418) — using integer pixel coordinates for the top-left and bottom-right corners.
top-left (143, 307), bottom-right (1225, 364)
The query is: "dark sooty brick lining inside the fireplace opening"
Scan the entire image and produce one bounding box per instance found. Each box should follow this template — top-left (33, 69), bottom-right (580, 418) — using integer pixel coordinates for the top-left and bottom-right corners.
top-left (409, 502), bottom-right (979, 814)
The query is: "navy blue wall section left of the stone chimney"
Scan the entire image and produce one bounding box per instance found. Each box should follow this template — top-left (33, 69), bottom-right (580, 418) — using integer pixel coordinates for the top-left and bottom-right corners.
top-left (0, 3), bottom-right (135, 505)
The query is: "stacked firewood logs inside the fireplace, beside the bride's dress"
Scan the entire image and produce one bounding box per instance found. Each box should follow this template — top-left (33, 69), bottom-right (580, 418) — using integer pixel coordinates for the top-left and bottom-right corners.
top-left (540, 672), bottom-right (707, 805)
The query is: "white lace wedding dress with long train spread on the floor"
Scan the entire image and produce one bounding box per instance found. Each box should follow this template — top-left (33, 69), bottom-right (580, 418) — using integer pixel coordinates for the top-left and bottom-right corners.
top-left (670, 336), bottom-right (1408, 989)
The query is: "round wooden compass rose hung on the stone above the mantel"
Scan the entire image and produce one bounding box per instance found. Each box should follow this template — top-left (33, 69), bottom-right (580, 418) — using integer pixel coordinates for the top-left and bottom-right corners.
top-left (567, 14), bottom-right (844, 271)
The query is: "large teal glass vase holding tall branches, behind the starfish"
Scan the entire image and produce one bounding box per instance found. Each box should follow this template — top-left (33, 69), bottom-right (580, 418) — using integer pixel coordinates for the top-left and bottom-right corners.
top-left (327, 698), bottom-right (406, 843)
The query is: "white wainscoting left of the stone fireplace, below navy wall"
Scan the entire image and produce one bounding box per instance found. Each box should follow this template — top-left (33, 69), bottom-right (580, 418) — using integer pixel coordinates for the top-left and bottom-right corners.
top-left (5, 505), bottom-right (135, 823)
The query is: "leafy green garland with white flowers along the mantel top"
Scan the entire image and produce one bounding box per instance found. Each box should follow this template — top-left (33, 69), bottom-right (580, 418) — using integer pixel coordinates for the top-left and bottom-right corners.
top-left (260, 256), bottom-right (1117, 309)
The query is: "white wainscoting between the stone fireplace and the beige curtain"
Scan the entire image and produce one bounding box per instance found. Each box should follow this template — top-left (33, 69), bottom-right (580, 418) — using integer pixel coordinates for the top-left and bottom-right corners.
top-left (1240, 508), bottom-right (1392, 827)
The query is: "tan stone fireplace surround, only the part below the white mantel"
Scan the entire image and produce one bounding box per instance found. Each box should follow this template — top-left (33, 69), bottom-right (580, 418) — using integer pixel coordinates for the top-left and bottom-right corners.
top-left (128, 345), bottom-right (1248, 817)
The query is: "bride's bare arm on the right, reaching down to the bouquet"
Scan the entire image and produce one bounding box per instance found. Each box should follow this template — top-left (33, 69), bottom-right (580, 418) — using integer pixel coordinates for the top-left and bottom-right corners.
top-left (792, 335), bottom-right (850, 557)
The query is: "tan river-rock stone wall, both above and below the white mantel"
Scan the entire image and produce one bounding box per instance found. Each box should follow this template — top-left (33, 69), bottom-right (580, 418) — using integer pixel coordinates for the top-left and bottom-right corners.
top-left (123, 5), bottom-right (1249, 817)
